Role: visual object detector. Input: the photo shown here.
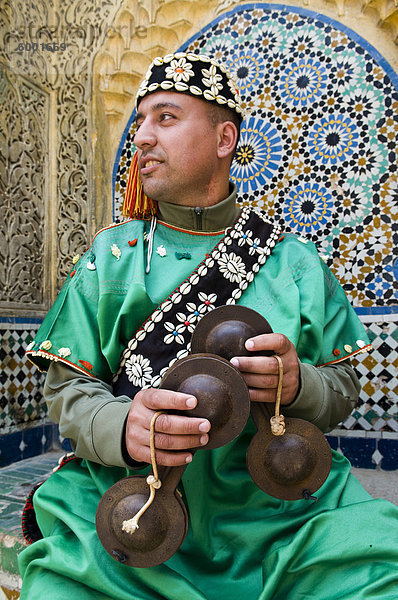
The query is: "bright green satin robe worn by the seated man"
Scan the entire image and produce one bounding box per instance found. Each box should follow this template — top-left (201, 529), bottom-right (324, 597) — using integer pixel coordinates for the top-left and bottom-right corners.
top-left (20, 210), bottom-right (398, 600)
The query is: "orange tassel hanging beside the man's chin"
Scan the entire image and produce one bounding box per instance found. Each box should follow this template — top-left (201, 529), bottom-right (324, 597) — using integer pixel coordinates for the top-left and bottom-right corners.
top-left (122, 152), bottom-right (158, 219)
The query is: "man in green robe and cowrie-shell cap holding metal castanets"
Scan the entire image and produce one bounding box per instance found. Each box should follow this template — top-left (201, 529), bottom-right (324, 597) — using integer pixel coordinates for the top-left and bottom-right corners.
top-left (20, 53), bottom-right (398, 600)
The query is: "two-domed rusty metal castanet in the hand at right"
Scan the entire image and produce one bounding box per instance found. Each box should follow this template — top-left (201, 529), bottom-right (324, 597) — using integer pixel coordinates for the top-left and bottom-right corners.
top-left (191, 305), bottom-right (332, 500)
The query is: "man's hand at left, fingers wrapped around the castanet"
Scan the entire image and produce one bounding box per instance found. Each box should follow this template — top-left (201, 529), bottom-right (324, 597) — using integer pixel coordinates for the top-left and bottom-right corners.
top-left (126, 388), bottom-right (210, 467)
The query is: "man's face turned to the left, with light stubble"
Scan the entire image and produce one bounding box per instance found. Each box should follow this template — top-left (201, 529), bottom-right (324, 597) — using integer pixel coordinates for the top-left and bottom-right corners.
top-left (134, 92), bottom-right (217, 206)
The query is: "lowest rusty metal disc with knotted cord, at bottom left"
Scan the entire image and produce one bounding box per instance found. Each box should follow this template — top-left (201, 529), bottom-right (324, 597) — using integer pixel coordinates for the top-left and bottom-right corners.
top-left (96, 475), bottom-right (188, 567)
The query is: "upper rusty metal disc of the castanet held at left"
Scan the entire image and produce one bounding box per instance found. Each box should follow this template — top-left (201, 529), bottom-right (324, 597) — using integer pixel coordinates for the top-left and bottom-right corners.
top-left (160, 354), bottom-right (250, 450)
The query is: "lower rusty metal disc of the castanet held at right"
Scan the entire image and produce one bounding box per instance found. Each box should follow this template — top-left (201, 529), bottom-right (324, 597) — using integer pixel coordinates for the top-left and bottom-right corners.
top-left (246, 418), bottom-right (332, 500)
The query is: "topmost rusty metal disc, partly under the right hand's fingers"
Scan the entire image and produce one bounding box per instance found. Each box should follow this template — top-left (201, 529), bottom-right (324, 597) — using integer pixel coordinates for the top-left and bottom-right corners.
top-left (191, 304), bottom-right (273, 360)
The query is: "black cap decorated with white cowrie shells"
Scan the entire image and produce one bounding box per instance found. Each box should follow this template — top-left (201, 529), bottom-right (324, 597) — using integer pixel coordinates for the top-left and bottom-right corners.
top-left (137, 52), bottom-right (243, 120)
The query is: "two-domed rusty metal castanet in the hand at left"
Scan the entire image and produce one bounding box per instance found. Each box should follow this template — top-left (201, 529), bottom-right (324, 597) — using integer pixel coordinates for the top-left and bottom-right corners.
top-left (96, 354), bottom-right (250, 567)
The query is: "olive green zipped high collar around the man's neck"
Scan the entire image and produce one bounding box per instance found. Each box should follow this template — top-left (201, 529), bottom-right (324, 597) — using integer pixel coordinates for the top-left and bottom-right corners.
top-left (158, 184), bottom-right (240, 231)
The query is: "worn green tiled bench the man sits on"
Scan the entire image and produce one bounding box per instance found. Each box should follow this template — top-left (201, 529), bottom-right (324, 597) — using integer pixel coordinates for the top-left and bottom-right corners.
top-left (0, 451), bottom-right (398, 600)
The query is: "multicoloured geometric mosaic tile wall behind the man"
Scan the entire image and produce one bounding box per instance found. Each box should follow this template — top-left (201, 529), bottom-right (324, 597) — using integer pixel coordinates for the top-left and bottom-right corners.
top-left (0, 3), bottom-right (398, 468)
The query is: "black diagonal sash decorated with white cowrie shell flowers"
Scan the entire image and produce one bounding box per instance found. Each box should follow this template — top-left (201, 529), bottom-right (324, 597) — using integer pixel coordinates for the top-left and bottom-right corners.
top-left (113, 208), bottom-right (280, 398)
